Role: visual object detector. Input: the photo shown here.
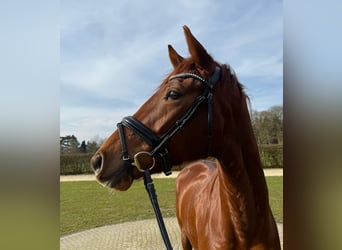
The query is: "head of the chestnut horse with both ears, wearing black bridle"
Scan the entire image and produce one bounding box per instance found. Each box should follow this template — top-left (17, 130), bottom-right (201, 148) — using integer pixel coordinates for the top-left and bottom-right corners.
top-left (91, 26), bottom-right (243, 190)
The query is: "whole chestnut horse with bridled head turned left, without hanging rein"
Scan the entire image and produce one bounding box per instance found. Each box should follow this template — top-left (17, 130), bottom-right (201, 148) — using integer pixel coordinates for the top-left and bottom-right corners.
top-left (91, 26), bottom-right (280, 249)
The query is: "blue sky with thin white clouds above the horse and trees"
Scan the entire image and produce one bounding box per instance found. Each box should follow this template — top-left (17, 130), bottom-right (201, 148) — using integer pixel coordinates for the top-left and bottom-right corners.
top-left (60, 0), bottom-right (283, 141)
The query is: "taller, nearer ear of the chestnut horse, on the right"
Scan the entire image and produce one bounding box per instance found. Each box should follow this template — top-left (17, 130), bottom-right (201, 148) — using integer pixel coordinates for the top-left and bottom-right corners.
top-left (183, 25), bottom-right (216, 72)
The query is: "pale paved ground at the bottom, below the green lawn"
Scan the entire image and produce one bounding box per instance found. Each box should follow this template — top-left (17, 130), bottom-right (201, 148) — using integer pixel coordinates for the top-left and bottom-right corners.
top-left (60, 217), bottom-right (283, 250)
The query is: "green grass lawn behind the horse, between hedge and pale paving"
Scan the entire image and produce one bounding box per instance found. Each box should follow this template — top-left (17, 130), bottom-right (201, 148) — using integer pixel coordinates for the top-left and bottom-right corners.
top-left (60, 177), bottom-right (283, 236)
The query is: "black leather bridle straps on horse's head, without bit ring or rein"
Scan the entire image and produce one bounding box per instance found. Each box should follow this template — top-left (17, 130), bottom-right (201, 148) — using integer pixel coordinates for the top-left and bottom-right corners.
top-left (117, 66), bottom-right (221, 175)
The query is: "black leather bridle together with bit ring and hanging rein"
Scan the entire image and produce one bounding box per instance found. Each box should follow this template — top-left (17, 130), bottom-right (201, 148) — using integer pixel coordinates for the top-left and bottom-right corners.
top-left (117, 66), bottom-right (221, 250)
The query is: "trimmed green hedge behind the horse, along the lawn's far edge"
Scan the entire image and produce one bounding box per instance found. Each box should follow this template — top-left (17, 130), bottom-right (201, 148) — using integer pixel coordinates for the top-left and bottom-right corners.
top-left (60, 145), bottom-right (283, 175)
